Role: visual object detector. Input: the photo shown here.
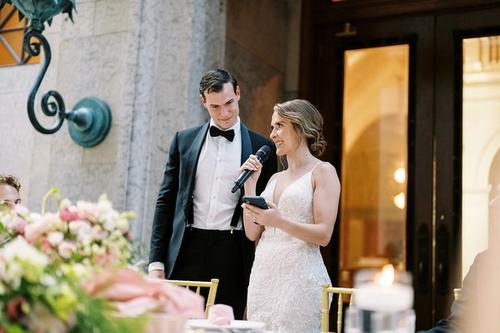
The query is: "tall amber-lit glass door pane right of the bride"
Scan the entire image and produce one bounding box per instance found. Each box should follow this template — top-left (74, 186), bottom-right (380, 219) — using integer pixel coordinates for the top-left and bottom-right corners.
top-left (339, 44), bottom-right (410, 287)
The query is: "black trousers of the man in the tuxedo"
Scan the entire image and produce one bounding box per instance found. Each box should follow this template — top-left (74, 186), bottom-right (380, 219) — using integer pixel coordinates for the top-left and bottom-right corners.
top-left (170, 227), bottom-right (250, 319)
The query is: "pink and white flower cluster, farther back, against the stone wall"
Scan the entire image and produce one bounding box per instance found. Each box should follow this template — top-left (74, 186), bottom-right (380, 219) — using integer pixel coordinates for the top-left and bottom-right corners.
top-left (0, 189), bottom-right (134, 269)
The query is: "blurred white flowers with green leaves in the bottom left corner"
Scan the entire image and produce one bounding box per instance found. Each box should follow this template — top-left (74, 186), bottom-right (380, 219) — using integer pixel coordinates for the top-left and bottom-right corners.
top-left (0, 236), bottom-right (144, 333)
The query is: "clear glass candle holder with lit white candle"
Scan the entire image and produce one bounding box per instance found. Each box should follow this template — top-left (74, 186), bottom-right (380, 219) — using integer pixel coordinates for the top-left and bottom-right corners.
top-left (345, 265), bottom-right (415, 333)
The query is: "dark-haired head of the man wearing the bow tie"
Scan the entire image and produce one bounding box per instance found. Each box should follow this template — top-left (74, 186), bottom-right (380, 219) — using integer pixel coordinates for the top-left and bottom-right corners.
top-left (199, 69), bottom-right (240, 129)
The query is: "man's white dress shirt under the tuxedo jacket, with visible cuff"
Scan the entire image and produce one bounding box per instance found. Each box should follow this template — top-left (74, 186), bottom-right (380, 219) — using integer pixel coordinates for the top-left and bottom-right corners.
top-left (148, 117), bottom-right (242, 271)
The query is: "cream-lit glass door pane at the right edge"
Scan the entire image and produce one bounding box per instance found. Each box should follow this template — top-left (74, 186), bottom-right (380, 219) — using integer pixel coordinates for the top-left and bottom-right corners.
top-left (462, 35), bottom-right (500, 277)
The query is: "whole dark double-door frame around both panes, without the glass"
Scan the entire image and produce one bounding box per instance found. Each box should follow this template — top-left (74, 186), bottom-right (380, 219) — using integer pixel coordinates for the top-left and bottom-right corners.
top-left (299, 0), bottom-right (500, 329)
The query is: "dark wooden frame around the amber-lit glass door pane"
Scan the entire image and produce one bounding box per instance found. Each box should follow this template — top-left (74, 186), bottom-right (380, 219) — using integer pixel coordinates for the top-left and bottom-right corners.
top-left (313, 17), bottom-right (434, 322)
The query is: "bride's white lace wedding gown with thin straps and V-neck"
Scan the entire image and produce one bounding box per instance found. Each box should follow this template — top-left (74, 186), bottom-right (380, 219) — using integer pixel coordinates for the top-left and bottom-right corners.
top-left (247, 169), bottom-right (330, 333)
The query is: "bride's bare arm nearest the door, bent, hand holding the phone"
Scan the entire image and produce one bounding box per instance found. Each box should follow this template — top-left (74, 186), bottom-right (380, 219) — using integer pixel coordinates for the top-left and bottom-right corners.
top-left (245, 163), bottom-right (340, 246)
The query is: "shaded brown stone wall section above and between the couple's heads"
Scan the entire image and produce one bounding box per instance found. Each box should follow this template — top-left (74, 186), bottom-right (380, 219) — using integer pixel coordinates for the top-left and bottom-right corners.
top-left (226, 0), bottom-right (301, 136)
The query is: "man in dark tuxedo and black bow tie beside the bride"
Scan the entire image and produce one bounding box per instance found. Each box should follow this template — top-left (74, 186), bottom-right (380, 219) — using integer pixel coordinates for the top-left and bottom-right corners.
top-left (148, 69), bottom-right (276, 319)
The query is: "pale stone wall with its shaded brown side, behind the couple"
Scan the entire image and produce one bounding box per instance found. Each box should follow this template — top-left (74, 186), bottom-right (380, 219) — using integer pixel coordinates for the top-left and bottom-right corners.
top-left (0, 0), bottom-right (300, 256)
